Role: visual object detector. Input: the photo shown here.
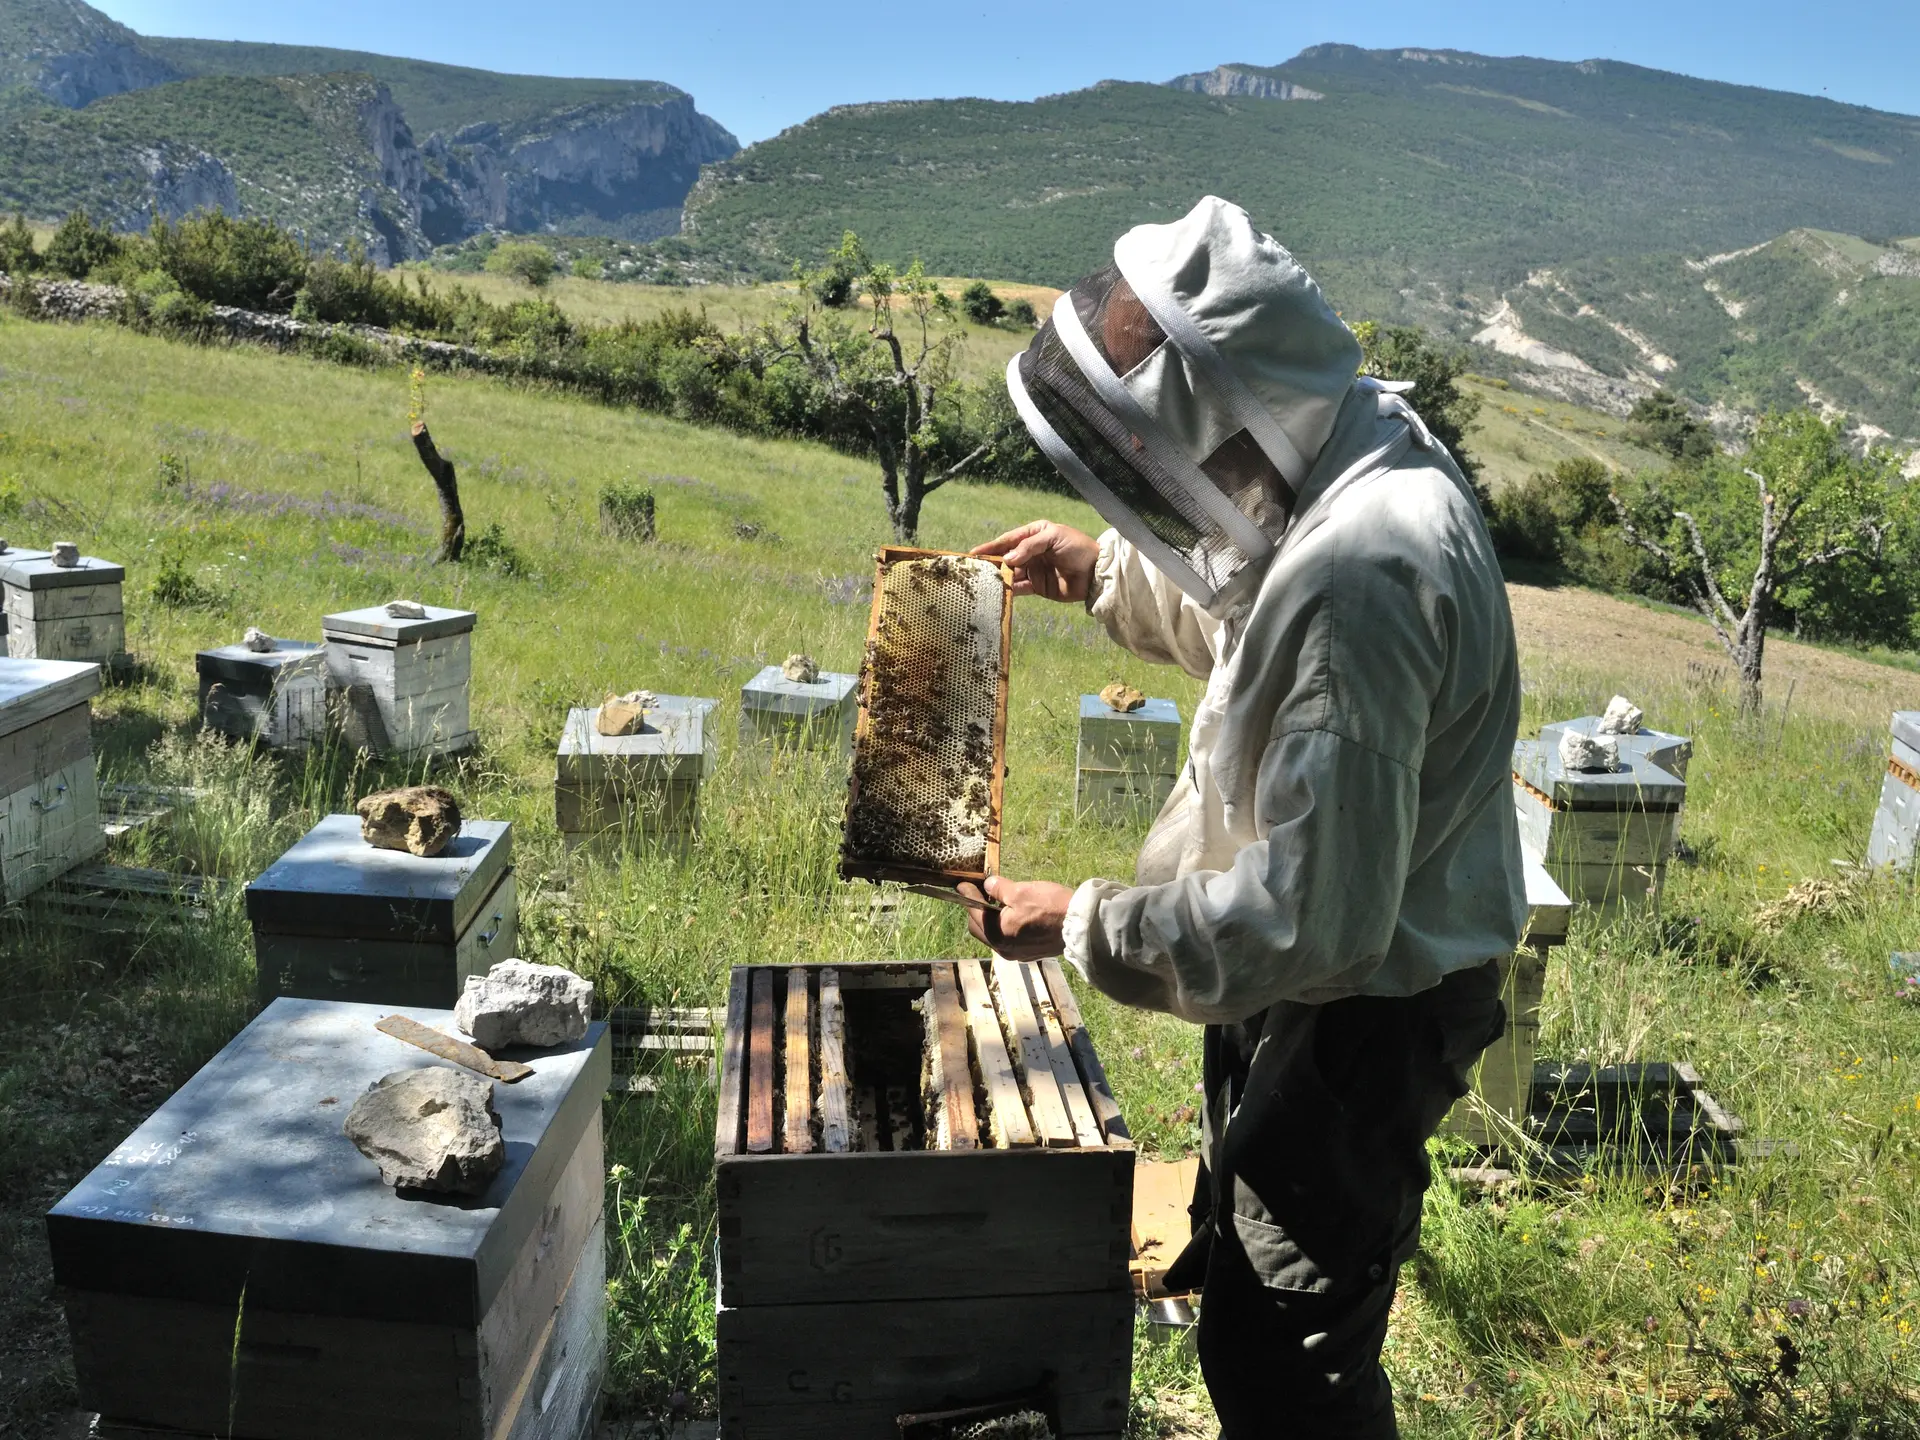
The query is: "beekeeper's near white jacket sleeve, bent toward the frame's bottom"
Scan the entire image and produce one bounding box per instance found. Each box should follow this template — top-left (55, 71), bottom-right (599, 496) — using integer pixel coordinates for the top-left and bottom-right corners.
top-left (1064, 529), bottom-right (1446, 1023)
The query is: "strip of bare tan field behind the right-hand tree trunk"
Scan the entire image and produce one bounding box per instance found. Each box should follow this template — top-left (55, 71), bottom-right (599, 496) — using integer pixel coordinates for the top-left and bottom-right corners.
top-left (1507, 586), bottom-right (1920, 726)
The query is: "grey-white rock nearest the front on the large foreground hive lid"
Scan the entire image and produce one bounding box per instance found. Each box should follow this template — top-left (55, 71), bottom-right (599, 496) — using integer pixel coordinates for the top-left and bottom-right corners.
top-left (346, 1066), bottom-right (507, 1194)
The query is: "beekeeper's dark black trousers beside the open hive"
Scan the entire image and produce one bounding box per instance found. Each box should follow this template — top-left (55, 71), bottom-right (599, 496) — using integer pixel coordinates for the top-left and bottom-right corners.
top-left (1167, 964), bottom-right (1505, 1440)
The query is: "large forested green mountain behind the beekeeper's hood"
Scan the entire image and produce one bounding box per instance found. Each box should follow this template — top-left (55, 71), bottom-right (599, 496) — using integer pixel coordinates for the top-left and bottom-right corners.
top-left (689, 52), bottom-right (1920, 315)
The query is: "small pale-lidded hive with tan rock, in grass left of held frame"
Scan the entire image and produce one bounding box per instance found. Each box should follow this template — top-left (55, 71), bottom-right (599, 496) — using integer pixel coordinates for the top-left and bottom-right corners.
top-left (553, 695), bottom-right (716, 849)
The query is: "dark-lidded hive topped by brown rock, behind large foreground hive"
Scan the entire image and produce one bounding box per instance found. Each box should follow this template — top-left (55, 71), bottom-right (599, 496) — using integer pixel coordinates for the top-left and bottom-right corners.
top-left (246, 814), bottom-right (518, 1008)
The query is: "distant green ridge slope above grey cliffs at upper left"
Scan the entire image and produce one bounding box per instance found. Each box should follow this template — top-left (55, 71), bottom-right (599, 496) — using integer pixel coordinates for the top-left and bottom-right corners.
top-left (144, 35), bottom-right (682, 140)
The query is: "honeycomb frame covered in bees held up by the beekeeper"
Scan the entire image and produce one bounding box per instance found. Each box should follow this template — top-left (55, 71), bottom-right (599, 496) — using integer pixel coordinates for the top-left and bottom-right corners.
top-left (841, 547), bottom-right (1014, 885)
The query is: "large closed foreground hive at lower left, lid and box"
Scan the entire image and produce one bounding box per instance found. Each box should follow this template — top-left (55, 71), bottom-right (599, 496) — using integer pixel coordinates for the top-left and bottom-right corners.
top-left (46, 1000), bottom-right (611, 1440)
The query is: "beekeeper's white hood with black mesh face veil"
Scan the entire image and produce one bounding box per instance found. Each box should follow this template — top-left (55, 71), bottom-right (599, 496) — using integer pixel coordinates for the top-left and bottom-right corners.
top-left (1006, 196), bottom-right (1361, 614)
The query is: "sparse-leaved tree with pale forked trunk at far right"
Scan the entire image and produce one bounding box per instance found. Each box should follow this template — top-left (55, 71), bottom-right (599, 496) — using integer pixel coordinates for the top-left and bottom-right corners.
top-left (1609, 411), bottom-right (1907, 714)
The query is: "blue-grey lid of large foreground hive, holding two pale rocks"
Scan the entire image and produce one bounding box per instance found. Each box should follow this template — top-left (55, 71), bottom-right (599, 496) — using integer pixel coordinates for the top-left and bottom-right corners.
top-left (46, 998), bottom-right (612, 1327)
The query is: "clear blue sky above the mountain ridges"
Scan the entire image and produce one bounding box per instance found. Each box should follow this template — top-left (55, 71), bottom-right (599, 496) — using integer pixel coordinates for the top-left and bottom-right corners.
top-left (96, 0), bottom-right (1920, 142)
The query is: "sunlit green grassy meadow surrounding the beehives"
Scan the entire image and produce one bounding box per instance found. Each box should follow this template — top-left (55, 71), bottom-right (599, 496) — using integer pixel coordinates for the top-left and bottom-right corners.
top-left (0, 317), bottom-right (1920, 1440)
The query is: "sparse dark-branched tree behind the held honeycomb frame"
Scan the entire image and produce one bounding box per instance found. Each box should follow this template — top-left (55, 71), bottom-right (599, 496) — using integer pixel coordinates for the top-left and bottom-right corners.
top-left (762, 230), bottom-right (1012, 543)
